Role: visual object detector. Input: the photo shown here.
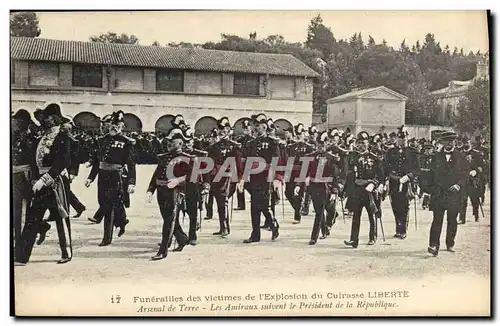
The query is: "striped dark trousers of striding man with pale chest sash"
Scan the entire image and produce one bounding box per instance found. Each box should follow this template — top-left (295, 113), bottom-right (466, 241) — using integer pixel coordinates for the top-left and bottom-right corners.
top-left (16, 177), bottom-right (73, 263)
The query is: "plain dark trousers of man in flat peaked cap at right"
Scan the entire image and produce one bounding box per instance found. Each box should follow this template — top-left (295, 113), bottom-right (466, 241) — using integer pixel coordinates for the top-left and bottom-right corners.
top-left (429, 207), bottom-right (458, 250)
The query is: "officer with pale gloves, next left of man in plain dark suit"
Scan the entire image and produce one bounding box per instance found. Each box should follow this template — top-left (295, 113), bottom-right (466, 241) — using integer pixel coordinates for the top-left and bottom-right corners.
top-left (386, 126), bottom-right (420, 239)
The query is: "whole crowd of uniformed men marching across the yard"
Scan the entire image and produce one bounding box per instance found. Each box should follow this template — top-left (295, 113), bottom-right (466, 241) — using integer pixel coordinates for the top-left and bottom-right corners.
top-left (12, 103), bottom-right (489, 265)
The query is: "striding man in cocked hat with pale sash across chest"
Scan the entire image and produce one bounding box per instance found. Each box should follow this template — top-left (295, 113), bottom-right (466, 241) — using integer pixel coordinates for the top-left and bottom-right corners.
top-left (15, 103), bottom-right (73, 266)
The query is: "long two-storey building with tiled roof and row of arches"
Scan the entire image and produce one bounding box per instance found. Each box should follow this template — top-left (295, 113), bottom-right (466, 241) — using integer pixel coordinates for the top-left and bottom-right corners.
top-left (11, 37), bottom-right (318, 134)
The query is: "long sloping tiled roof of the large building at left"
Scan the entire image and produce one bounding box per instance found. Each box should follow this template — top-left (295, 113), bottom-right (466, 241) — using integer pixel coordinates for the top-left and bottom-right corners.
top-left (10, 37), bottom-right (319, 77)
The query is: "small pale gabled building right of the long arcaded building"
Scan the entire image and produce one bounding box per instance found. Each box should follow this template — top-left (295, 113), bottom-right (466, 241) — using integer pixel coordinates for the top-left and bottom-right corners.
top-left (326, 86), bottom-right (407, 134)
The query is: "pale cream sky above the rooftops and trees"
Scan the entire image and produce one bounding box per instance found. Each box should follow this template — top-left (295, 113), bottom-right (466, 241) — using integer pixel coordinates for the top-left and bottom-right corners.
top-left (38, 11), bottom-right (488, 53)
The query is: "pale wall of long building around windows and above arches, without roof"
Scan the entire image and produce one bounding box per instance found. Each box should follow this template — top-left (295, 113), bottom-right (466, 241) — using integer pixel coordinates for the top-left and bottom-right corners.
top-left (12, 61), bottom-right (313, 131)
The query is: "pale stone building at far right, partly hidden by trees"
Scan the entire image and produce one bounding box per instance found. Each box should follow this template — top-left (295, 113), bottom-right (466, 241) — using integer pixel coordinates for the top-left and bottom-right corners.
top-left (431, 54), bottom-right (489, 124)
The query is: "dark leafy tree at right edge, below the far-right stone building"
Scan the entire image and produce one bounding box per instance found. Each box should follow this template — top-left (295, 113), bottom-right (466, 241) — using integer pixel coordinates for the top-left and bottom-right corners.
top-left (453, 78), bottom-right (491, 134)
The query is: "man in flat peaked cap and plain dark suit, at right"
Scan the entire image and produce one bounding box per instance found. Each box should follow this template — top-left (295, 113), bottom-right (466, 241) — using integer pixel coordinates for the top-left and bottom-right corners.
top-left (427, 132), bottom-right (468, 256)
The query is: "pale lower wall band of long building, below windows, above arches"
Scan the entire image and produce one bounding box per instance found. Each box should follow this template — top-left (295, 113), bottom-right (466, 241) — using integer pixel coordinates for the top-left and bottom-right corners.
top-left (12, 89), bottom-right (312, 131)
